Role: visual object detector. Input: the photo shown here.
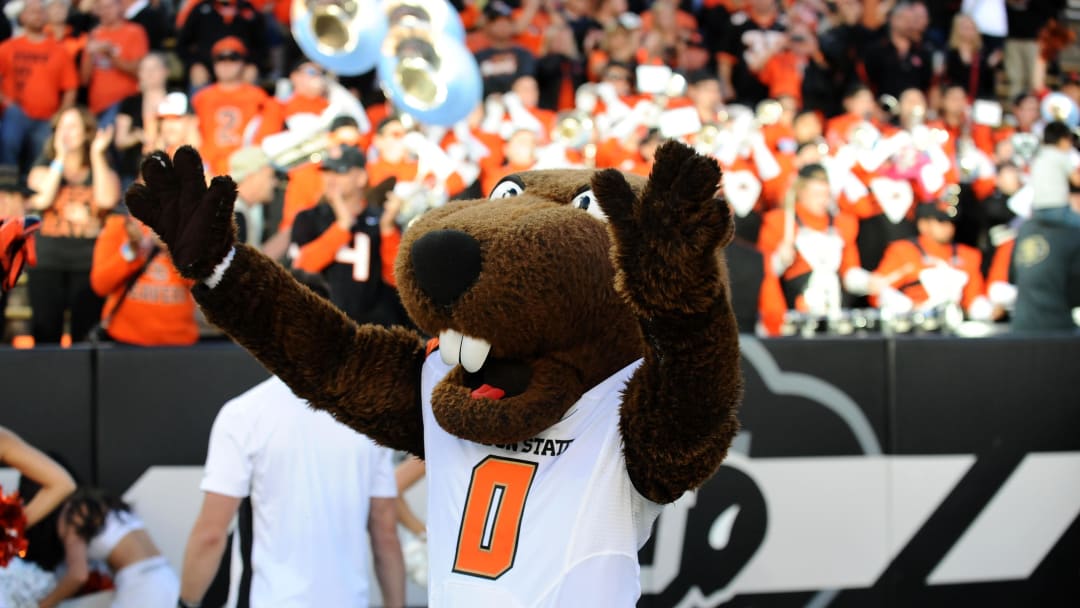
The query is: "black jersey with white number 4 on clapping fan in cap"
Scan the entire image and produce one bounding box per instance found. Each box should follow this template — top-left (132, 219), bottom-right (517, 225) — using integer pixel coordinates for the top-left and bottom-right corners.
top-left (293, 202), bottom-right (404, 325)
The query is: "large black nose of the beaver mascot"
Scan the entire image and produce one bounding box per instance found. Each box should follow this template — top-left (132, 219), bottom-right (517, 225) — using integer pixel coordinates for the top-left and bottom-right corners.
top-left (411, 230), bottom-right (480, 307)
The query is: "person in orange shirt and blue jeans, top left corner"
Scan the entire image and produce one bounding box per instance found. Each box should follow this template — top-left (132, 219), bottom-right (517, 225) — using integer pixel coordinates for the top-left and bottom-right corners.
top-left (0, 0), bottom-right (79, 175)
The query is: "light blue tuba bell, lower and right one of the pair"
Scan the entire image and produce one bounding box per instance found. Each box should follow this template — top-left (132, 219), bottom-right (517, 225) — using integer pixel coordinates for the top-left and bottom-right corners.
top-left (378, 0), bottom-right (483, 126)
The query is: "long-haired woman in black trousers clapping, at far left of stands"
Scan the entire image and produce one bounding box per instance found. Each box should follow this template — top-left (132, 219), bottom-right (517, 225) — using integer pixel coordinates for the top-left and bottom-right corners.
top-left (28, 107), bottom-right (120, 343)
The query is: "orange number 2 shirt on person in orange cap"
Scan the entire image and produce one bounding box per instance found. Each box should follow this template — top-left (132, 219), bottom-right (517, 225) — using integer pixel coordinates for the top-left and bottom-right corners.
top-left (191, 83), bottom-right (283, 175)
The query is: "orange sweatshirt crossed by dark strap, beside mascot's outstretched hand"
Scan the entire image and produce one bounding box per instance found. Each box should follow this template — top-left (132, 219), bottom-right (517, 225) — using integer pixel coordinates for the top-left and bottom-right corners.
top-left (90, 214), bottom-right (199, 347)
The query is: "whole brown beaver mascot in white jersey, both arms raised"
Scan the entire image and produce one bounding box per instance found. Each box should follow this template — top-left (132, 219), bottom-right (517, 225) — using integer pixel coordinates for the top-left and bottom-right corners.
top-left (127, 143), bottom-right (742, 606)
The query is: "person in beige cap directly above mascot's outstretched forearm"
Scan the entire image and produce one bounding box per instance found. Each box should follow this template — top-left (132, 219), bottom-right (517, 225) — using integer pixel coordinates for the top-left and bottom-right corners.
top-left (229, 146), bottom-right (288, 259)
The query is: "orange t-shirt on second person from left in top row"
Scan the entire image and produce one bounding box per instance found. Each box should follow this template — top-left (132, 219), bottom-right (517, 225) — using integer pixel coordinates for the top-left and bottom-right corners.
top-left (83, 22), bottom-right (150, 113)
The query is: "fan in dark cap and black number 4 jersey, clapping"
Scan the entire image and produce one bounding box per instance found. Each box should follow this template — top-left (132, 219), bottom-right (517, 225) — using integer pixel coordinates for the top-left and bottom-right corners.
top-left (289, 146), bottom-right (404, 326)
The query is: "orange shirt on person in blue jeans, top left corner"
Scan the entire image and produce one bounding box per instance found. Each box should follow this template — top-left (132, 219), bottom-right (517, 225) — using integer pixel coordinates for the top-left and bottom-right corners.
top-left (0, 36), bottom-right (79, 120)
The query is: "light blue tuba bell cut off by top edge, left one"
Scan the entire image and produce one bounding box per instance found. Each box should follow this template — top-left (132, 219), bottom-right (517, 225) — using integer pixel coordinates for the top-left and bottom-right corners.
top-left (291, 0), bottom-right (387, 76)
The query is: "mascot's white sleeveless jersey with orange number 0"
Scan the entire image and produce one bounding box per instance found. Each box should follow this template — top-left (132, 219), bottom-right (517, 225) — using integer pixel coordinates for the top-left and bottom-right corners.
top-left (421, 353), bottom-right (662, 608)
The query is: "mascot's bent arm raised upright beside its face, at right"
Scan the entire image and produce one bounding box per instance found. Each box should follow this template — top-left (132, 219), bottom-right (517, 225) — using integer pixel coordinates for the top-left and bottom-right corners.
top-left (593, 141), bottom-right (742, 503)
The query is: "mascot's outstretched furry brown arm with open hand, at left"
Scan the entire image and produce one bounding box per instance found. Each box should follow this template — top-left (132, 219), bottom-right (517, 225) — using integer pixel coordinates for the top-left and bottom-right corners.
top-left (126, 147), bottom-right (424, 456)
